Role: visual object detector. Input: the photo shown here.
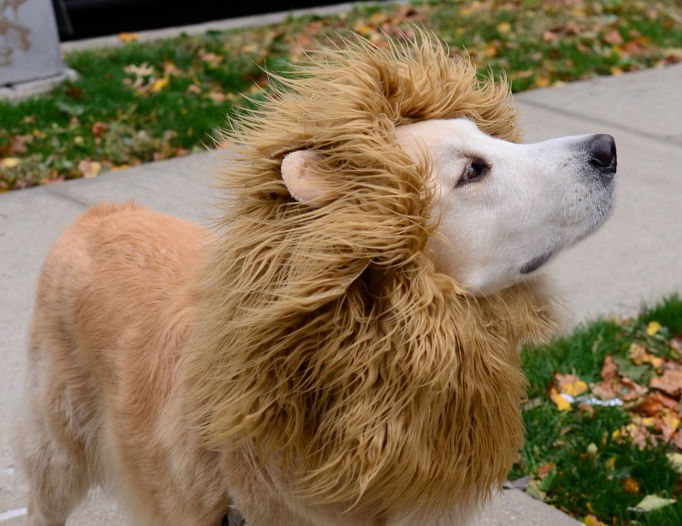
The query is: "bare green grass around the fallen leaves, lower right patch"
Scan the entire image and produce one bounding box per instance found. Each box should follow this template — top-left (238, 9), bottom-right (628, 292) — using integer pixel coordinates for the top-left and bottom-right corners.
top-left (510, 295), bottom-right (682, 526)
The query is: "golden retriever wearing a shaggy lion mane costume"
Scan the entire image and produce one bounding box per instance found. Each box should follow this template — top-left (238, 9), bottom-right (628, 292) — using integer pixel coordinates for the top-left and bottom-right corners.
top-left (18, 35), bottom-right (616, 526)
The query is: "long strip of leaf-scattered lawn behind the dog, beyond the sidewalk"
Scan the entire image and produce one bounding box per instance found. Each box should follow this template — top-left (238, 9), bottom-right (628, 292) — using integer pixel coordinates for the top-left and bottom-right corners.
top-left (0, 0), bottom-right (682, 192)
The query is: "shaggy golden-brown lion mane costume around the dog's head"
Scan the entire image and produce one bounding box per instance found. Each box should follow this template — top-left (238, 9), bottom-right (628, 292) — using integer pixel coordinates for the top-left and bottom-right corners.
top-left (183, 34), bottom-right (550, 517)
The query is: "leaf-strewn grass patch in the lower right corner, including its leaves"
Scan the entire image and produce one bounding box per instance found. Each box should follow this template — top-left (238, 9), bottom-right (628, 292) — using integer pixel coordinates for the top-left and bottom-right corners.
top-left (510, 296), bottom-right (682, 526)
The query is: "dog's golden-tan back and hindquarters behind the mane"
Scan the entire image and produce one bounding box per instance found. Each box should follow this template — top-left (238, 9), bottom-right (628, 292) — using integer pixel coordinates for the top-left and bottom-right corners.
top-left (18, 204), bottom-right (225, 526)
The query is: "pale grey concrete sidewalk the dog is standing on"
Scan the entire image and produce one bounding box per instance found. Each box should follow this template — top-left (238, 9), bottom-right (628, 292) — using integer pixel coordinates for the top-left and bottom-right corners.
top-left (0, 65), bottom-right (682, 526)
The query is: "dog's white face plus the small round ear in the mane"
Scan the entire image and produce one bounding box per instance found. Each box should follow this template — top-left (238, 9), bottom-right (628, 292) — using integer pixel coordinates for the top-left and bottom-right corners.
top-left (282, 119), bottom-right (616, 295)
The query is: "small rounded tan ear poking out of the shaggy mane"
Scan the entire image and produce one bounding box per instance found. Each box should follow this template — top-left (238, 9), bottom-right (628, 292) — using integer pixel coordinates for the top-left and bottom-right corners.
top-left (282, 150), bottom-right (329, 206)
